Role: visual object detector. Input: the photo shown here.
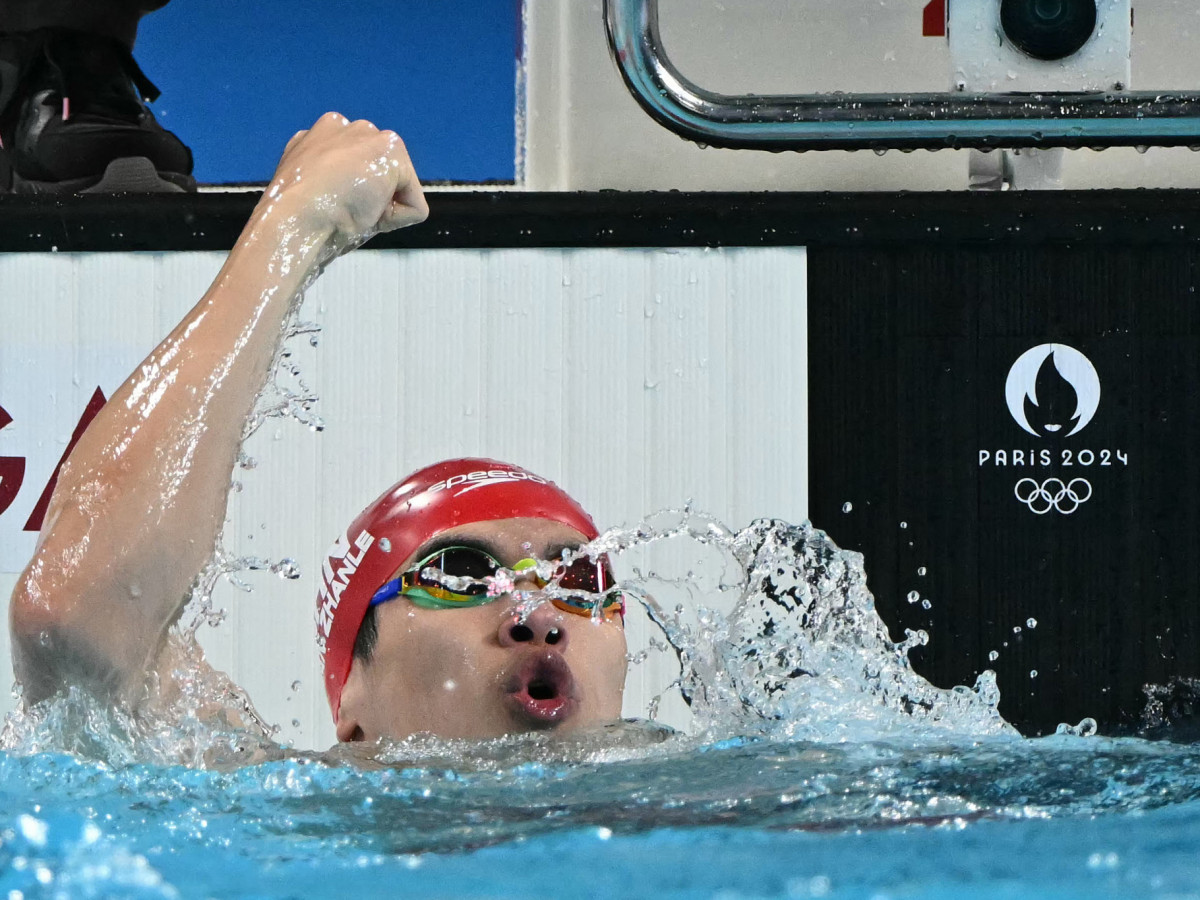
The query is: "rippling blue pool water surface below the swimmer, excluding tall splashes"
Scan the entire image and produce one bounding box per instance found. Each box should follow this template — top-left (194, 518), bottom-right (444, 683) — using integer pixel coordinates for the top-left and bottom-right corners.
top-left (0, 738), bottom-right (1200, 898)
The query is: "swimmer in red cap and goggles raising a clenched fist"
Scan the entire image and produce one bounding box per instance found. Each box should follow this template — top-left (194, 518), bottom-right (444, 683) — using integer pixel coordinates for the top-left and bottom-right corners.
top-left (10, 113), bottom-right (625, 742)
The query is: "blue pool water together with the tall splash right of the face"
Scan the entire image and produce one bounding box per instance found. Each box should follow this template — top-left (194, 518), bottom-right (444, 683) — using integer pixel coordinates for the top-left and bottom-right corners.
top-left (0, 518), bottom-right (1200, 898)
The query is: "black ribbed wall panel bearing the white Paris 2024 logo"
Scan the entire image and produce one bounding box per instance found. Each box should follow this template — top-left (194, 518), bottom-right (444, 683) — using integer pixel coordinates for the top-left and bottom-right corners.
top-left (809, 244), bottom-right (1200, 732)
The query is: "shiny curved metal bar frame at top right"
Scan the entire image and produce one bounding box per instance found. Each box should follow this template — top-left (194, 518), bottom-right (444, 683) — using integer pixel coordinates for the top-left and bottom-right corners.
top-left (605, 0), bottom-right (1200, 150)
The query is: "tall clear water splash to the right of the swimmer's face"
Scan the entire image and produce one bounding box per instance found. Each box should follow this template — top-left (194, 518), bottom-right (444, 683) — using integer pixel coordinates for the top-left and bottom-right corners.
top-left (589, 509), bottom-right (1016, 740)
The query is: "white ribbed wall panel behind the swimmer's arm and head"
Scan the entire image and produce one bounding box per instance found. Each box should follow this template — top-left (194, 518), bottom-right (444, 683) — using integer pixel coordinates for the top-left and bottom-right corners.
top-left (0, 248), bottom-right (808, 748)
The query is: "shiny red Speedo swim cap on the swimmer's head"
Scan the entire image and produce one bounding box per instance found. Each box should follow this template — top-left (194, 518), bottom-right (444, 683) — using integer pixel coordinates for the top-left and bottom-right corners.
top-left (317, 460), bottom-right (599, 720)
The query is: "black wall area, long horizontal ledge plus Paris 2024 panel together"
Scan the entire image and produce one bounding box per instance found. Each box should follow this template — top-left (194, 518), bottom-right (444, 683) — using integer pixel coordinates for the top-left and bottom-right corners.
top-left (0, 191), bottom-right (1200, 732)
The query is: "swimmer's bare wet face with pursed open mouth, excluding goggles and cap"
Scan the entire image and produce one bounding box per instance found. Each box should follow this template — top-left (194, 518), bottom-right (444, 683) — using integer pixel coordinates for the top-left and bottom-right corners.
top-left (337, 518), bottom-right (625, 740)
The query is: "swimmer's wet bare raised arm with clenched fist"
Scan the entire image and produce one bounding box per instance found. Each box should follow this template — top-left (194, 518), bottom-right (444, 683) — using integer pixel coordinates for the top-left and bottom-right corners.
top-left (11, 114), bottom-right (427, 701)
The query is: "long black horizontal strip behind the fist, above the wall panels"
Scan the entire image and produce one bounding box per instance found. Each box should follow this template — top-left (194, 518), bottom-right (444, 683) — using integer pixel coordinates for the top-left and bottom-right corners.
top-left (0, 190), bottom-right (1200, 252)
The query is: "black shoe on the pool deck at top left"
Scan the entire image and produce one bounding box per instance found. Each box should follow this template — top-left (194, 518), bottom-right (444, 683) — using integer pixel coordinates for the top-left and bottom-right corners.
top-left (0, 29), bottom-right (196, 193)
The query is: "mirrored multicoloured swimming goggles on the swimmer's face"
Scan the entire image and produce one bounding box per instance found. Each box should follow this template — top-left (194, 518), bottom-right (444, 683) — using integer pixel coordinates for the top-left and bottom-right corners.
top-left (370, 547), bottom-right (625, 620)
